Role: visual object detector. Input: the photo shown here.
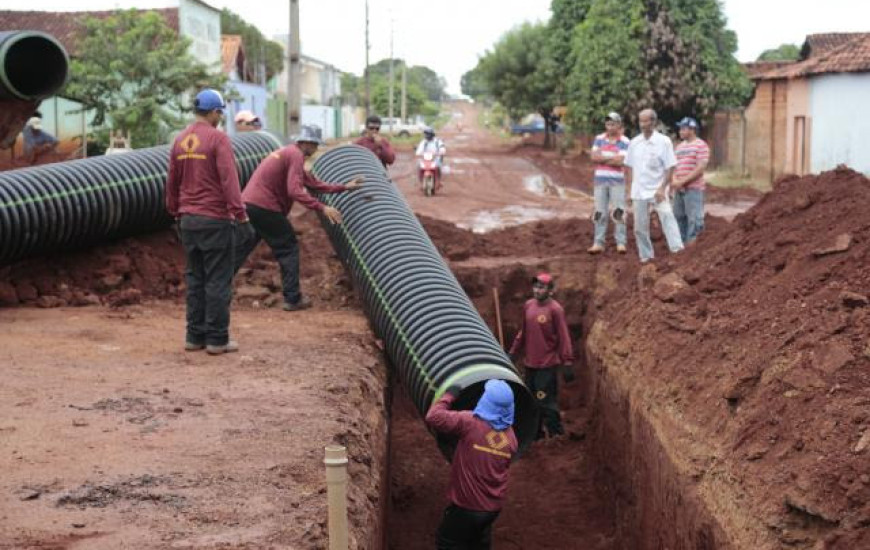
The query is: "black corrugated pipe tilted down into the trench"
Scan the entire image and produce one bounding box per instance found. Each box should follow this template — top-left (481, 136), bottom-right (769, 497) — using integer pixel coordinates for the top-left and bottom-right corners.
top-left (314, 145), bottom-right (538, 459)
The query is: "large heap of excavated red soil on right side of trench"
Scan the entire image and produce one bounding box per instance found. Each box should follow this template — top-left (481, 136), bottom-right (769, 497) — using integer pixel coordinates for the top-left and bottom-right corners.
top-left (589, 169), bottom-right (870, 549)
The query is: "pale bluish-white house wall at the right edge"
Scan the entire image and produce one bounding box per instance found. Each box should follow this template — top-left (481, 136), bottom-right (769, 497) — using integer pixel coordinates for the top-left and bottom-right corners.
top-left (810, 73), bottom-right (870, 174)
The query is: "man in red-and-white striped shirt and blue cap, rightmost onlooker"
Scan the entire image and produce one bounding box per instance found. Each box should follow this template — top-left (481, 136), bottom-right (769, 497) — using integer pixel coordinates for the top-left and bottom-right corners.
top-left (671, 117), bottom-right (710, 244)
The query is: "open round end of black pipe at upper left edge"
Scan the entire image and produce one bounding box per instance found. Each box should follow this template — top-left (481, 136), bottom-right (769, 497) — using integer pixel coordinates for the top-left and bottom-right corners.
top-left (0, 31), bottom-right (69, 101)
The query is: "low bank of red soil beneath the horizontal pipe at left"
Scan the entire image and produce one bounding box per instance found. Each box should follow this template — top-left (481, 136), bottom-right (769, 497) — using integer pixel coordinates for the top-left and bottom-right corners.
top-left (0, 211), bottom-right (354, 309)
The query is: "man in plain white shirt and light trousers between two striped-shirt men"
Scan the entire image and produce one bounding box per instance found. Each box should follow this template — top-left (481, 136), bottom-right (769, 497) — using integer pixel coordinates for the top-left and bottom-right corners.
top-left (625, 109), bottom-right (683, 263)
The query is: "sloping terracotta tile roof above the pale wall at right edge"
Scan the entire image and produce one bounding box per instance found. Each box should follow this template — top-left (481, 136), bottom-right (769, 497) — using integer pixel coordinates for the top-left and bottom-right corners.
top-left (756, 33), bottom-right (870, 80)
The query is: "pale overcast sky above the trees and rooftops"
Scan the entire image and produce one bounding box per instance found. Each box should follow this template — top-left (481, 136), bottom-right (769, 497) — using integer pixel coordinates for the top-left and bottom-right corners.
top-left (8, 0), bottom-right (870, 92)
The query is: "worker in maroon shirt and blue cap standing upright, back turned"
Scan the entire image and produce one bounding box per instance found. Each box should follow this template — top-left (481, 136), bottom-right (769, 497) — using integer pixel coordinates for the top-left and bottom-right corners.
top-left (166, 89), bottom-right (250, 355)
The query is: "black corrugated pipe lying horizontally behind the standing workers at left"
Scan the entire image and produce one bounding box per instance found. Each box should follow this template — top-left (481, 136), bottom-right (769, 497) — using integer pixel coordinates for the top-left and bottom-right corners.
top-left (0, 132), bottom-right (284, 265)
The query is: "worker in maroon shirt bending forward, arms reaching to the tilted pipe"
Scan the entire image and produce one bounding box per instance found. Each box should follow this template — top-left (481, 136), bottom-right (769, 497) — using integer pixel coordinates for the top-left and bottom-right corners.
top-left (235, 124), bottom-right (363, 311)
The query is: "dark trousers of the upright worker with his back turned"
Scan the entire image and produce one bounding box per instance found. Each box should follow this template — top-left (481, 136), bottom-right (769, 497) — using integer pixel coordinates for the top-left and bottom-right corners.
top-left (179, 215), bottom-right (235, 346)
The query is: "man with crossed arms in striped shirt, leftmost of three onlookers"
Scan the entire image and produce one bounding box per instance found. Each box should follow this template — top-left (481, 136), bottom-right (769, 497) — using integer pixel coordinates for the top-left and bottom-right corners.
top-left (587, 113), bottom-right (630, 254)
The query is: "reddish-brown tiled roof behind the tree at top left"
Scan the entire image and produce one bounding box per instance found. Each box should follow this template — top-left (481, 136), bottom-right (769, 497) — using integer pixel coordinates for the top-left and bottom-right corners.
top-left (0, 8), bottom-right (178, 57)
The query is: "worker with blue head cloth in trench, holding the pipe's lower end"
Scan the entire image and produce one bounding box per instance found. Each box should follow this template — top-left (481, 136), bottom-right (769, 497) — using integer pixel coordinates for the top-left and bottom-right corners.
top-left (426, 380), bottom-right (518, 550)
